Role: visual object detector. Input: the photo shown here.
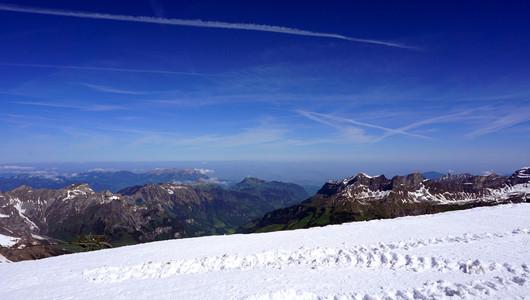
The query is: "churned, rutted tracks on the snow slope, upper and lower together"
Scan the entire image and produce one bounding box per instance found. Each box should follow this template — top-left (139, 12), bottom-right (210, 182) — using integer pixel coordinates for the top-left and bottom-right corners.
top-left (84, 228), bottom-right (530, 299)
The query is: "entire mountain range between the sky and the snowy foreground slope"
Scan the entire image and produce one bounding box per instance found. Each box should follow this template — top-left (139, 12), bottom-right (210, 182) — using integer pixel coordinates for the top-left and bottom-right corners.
top-left (0, 168), bottom-right (530, 261)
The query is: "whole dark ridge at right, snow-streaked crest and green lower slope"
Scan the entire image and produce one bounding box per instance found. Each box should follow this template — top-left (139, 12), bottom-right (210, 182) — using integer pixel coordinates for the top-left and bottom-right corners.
top-left (238, 168), bottom-right (530, 233)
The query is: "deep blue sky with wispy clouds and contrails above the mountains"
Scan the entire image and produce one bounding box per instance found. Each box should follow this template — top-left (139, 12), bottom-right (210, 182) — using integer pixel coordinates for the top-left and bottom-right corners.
top-left (0, 0), bottom-right (530, 173)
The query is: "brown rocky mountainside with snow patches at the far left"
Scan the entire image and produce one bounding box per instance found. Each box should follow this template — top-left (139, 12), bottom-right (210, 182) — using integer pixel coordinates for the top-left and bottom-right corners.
top-left (0, 184), bottom-right (159, 260)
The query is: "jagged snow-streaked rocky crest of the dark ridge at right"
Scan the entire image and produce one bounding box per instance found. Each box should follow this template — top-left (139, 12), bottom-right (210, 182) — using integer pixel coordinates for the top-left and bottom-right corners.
top-left (318, 168), bottom-right (530, 205)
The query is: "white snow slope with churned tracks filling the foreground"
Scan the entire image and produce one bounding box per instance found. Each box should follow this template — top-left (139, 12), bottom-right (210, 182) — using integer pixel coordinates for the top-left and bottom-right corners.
top-left (0, 204), bottom-right (530, 299)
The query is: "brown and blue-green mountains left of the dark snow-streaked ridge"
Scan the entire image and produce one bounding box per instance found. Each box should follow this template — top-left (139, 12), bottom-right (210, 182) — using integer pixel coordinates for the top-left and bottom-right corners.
top-left (0, 177), bottom-right (308, 261)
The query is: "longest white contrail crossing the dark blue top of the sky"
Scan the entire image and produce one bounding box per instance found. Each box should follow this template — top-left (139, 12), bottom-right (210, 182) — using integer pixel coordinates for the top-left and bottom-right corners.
top-left (0, 3), bottom-right (419, 50)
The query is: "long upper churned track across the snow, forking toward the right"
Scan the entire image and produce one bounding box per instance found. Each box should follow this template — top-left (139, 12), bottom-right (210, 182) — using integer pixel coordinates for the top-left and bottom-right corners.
top-left (84, 228), bottom-right (530, 284)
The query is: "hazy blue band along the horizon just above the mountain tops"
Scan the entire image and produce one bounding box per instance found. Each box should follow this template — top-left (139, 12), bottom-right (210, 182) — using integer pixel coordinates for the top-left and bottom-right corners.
top-left (0, 161), bottom-right (526, 186)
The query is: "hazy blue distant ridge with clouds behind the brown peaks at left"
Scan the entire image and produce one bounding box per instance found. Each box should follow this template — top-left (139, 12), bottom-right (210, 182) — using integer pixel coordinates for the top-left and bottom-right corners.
top-left (0, 169), bottom-right (211, 193)
